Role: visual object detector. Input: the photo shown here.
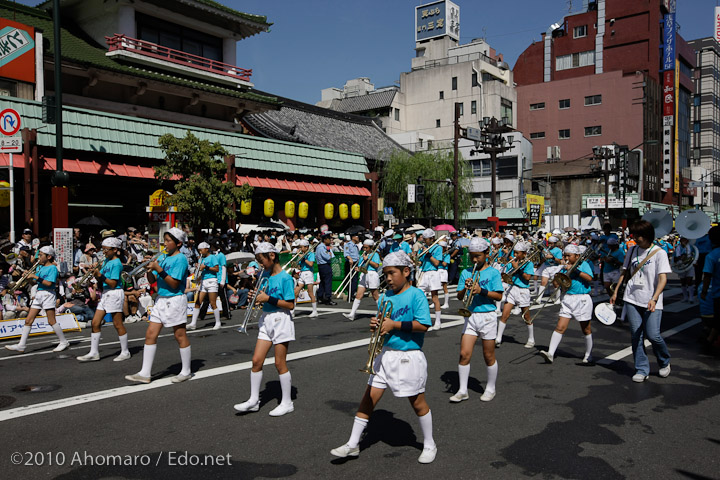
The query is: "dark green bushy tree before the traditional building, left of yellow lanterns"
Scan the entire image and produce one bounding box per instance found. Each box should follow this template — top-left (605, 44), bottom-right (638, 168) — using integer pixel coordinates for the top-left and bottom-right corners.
top-left (154, 131), bottom-right (253, 229)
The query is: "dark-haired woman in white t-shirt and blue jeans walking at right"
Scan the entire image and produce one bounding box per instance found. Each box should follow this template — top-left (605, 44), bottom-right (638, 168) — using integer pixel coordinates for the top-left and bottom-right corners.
top-left (610, 220), bottom-right (672, 383)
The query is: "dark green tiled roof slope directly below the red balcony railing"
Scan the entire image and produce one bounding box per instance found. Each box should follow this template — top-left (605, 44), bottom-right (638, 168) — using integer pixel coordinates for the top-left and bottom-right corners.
top-left (0, 0), bottom-right (277, 105)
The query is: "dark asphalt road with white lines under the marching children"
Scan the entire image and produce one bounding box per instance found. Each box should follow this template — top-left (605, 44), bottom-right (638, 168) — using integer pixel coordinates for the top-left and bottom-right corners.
top-left (0, 281), bottom-right (720, 479)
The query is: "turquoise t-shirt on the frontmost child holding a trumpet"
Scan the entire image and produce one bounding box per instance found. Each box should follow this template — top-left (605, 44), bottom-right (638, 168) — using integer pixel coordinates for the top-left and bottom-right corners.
top-left (378, 287), bottom-right (432, 351)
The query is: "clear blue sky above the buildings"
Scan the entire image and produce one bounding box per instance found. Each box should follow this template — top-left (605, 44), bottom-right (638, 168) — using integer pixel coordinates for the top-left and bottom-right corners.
top-left (19, 0), bottom-right (718, 104)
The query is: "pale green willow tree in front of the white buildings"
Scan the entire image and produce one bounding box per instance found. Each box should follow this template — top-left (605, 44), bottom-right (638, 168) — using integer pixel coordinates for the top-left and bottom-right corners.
top-left (380, 150), bottom-right (472, 222)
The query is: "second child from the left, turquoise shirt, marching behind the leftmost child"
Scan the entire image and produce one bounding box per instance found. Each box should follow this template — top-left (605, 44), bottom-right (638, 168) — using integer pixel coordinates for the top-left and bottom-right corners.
top-left (77, 237), bottom-right (130, 362)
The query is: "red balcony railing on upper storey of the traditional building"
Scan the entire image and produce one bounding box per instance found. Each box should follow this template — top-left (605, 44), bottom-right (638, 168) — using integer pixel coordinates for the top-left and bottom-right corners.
top-left (105, 33), bottom-right (252, 82)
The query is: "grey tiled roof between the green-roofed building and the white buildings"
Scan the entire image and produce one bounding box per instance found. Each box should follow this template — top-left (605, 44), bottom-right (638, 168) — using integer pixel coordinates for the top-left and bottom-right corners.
top-left (242, 93), bottom-right (403, 161)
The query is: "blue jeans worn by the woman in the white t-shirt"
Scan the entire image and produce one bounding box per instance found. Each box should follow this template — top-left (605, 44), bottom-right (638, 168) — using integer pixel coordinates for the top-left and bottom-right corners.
top-left (625, 302), bottom-right (670, 375)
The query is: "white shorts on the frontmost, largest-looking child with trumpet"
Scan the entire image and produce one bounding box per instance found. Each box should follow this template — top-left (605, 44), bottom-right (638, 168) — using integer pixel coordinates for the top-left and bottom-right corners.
top-left (368, 348), bottom-right (427, 397)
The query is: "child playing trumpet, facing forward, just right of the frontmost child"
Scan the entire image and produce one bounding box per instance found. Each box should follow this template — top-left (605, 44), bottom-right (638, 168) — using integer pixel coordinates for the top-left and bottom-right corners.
top-left (450, 237), bottom-right (503, 403)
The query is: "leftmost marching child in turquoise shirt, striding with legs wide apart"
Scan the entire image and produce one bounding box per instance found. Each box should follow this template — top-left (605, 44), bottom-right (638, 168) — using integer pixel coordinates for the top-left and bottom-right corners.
top-left (5, 246), bottom-right (70, 353)
